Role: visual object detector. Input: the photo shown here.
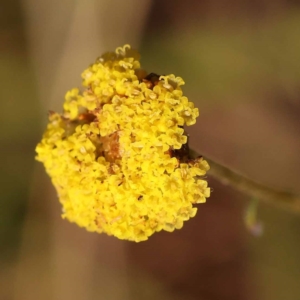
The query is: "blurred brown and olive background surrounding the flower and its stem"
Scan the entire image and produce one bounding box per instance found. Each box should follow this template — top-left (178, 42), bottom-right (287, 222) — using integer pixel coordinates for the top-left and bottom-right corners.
top-left (0, 0), bottom-right (300, 300)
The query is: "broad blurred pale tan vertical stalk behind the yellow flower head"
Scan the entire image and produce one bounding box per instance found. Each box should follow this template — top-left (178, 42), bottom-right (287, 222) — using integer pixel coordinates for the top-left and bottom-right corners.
top-left (14, 0), bottom-right (150, 300)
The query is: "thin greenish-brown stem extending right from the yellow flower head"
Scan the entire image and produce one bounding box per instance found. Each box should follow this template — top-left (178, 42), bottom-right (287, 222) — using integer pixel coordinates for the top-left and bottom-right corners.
top-left (190, 150), bottom-right (300, 213)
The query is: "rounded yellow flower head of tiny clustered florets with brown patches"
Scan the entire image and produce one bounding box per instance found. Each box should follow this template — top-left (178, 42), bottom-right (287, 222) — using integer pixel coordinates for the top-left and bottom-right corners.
top-left (36, 45), bottom-right (210, 242)
